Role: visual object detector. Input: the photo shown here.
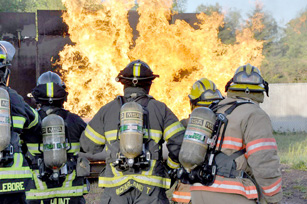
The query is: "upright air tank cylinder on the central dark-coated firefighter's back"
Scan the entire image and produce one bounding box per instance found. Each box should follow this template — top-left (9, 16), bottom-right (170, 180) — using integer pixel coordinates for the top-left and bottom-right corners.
top-left (119, 102), bottom-right (143, 159)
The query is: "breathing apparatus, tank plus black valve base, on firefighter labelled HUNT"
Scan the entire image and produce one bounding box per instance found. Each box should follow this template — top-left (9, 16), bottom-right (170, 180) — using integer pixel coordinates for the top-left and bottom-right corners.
top-left (38, 110), bottom-right (76, 182)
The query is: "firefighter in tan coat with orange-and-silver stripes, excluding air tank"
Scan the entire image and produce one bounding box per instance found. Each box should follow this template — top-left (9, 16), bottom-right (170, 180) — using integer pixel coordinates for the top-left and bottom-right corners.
top-left (191, 64), bottom-right (282, 204)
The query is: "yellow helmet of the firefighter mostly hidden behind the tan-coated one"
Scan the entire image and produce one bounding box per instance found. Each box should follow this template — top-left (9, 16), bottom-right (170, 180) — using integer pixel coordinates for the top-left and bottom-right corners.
top-left (189, 78), bottom-right (223, 109)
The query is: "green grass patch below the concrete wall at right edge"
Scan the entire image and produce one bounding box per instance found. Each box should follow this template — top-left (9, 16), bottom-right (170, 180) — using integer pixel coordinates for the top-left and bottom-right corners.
top-left (274, 133), bottom-right (307, 171)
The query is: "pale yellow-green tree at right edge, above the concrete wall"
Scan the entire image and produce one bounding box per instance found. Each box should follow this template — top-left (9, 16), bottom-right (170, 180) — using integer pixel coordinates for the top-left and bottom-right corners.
top-left (262, 9), bottom-right (307, 83)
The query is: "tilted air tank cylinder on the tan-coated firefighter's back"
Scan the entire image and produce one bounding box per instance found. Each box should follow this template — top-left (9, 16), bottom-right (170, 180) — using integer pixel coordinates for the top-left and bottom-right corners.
top-left (179, 107), bottom-right (216, 172)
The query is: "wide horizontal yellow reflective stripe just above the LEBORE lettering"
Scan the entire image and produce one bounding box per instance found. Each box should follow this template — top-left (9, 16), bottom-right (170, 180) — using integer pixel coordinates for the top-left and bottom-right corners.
top-left (0, 167), bottom-right (32, 179)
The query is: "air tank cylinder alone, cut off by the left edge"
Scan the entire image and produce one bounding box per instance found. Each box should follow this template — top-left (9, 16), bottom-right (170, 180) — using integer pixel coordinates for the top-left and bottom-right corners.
top-left (0, 87), bottom-right (11, 151)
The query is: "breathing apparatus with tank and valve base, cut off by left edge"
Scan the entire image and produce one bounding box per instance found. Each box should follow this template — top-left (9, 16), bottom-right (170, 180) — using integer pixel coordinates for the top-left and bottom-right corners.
top-left (0, 86), bottom-right (14, 163)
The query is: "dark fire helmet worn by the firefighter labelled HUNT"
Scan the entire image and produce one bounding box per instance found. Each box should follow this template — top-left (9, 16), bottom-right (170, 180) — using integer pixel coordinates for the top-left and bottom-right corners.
top-left (32, 71), bottom-right (68, 106)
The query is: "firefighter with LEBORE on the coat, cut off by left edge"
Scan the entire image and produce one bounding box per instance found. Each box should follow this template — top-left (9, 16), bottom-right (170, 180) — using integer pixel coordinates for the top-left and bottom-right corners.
top-left (0, 41), bottom-right (40, 204)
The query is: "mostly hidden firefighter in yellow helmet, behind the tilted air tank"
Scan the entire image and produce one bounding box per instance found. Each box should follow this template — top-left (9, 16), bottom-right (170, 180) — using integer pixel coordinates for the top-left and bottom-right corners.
top-left (172, 78), bottom-right (223, 203)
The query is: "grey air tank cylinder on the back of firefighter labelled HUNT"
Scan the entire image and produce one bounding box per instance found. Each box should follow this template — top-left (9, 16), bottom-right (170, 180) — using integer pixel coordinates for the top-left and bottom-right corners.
top-left (42, 114), bottom-right (67, 170)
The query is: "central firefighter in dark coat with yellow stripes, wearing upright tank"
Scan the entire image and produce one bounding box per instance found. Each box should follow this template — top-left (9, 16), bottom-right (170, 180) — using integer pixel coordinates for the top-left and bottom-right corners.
top-left (80, 60), bottom-right (184, 204)
